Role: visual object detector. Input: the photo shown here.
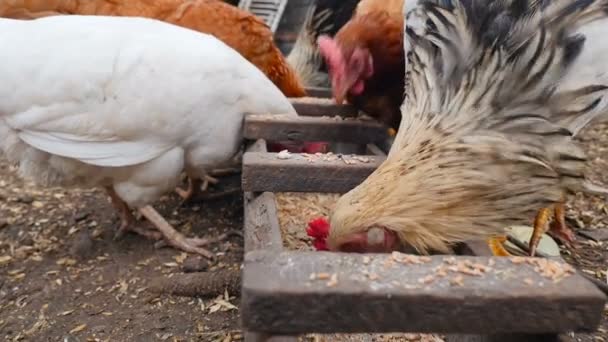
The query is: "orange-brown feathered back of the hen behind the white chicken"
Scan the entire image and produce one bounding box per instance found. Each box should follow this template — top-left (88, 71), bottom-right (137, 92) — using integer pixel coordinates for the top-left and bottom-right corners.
top-left (0, 0), bottom-right (306, 97)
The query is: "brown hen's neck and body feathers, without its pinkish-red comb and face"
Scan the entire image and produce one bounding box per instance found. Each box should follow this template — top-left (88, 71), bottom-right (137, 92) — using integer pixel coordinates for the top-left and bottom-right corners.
top-left (336, 0), bottom-right (405, 129)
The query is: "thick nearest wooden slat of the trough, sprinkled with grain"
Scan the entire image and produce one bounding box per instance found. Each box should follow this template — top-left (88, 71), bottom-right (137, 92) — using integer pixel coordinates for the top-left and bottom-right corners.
top-left (241, 251), bottom-right (606, 334)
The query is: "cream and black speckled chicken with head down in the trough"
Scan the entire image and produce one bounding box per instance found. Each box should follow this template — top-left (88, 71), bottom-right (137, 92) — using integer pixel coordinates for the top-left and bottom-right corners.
top-left (319, 0), bottom-right (608, 253)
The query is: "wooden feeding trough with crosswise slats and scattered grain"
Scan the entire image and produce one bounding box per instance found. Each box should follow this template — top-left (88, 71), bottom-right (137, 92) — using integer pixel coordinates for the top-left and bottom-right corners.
top-left (241, 94), bottom-right (606, 341)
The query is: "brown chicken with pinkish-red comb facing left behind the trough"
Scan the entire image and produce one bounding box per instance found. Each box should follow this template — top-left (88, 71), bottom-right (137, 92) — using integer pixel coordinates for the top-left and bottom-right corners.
top-left (318, 0), bottom-right (405, 130)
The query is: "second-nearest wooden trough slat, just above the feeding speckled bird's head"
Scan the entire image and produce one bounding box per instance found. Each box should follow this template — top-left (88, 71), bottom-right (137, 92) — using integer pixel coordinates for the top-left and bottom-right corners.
top-left (242, 152), bottom-right (384, 193)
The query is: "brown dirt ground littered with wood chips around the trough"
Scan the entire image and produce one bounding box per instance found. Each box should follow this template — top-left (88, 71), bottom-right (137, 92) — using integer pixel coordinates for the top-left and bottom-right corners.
top-left (0, 124), bottom-right (608, 342)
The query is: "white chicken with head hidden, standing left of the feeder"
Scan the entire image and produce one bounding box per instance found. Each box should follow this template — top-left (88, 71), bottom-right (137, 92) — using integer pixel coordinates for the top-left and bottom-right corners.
top-left (0, 15), bottom-right (296, 257)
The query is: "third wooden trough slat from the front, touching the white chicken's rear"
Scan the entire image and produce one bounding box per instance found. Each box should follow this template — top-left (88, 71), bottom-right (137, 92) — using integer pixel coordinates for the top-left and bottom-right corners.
top-left (243, 115), bottom-right (387, 144)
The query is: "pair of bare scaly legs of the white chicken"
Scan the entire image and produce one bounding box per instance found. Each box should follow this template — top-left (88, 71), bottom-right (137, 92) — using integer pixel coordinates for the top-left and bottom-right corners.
top-left (106, 187), bottom-right (218, 259)
